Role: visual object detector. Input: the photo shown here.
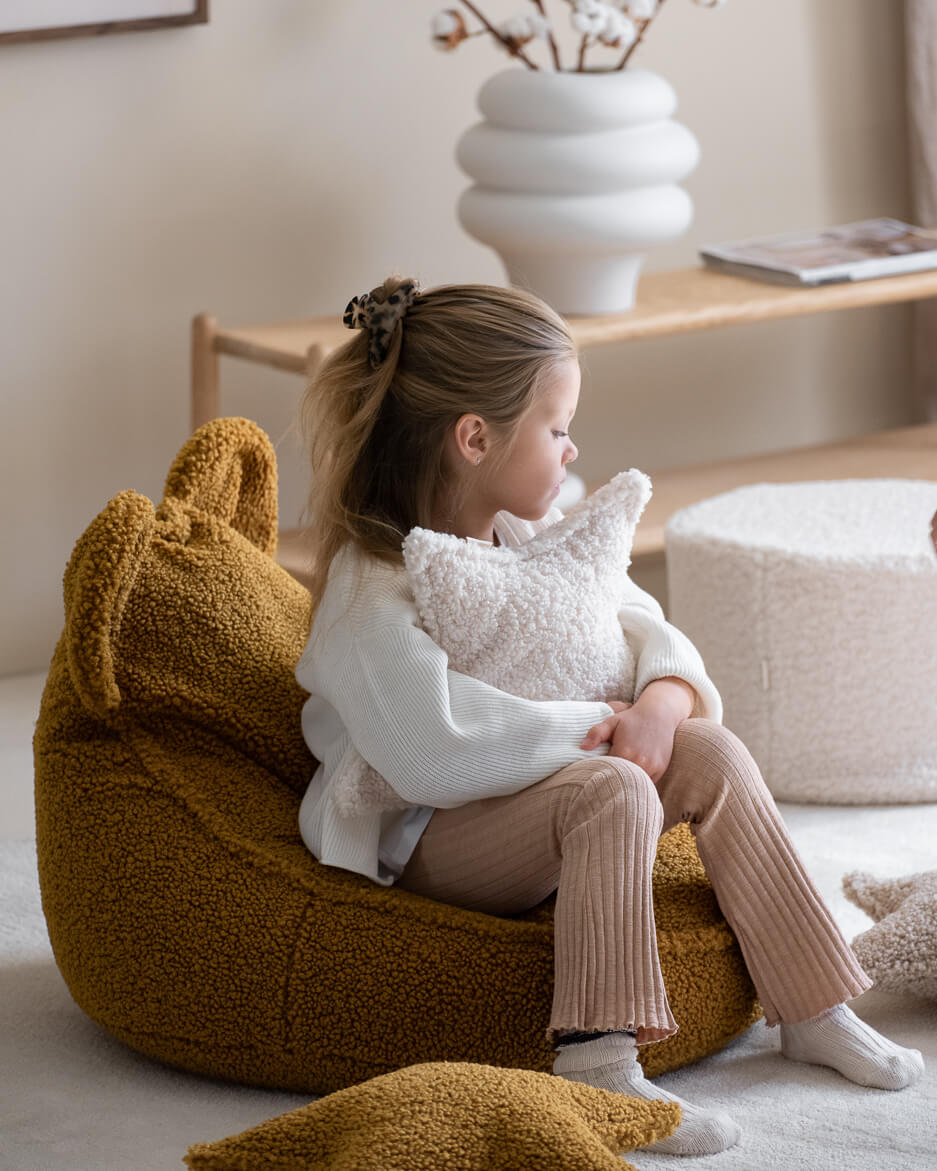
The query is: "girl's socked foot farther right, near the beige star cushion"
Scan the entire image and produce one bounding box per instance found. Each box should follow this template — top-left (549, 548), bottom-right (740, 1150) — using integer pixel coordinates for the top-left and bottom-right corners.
top-left (780, 1005), bottom-right (924, 1090)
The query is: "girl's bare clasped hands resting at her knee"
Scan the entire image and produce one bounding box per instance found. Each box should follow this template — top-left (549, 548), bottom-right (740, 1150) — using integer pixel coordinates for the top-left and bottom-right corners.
top-left (581, 677), bottom-right (696, 783)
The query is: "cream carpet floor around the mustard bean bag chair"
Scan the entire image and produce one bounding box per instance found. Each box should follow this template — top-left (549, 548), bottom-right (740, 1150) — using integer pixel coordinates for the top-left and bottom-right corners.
top-left (0, 806), bottom-right (937, 1171)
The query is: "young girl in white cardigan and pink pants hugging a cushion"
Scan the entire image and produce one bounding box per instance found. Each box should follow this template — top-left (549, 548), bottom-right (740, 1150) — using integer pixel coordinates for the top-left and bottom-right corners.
top-left (296, 279), bottom-right (923, 1155)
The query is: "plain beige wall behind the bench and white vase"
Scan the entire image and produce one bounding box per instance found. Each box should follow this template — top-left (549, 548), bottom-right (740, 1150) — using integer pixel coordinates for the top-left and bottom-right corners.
top-left (0, 0), bottom-right (911, 674)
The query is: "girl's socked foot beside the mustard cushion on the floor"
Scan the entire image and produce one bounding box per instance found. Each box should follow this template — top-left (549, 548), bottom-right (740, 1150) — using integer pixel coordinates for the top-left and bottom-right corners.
top-left (553, 1033), bottom-right (741, 1155)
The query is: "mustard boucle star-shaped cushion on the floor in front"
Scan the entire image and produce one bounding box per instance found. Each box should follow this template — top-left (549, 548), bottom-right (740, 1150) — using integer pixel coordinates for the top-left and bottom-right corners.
top-left (185, 1062), bottom-right (679, 1171)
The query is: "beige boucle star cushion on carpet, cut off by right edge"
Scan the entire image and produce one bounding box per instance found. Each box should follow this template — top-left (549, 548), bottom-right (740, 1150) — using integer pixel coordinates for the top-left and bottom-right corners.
top-left (842, 870), bottom-right (937, 1000)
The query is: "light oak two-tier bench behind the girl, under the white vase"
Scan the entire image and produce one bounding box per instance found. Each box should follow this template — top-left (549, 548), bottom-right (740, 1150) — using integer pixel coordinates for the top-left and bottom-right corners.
top-left (192, 268), bottom-right (937, 585)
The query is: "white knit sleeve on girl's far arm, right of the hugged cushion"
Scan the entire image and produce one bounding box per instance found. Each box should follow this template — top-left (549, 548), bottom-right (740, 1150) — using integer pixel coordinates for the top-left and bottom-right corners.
top-left (618, 580), bottom-right (723, 723)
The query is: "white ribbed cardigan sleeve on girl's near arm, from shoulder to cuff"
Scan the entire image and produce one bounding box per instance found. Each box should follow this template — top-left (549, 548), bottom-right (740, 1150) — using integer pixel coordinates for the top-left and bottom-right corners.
top-left (296, 541), bottom-right (611, 808)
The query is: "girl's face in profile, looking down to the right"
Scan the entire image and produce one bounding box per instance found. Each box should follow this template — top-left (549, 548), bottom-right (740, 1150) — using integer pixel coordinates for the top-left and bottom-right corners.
top-left (483, 359), bottom-right (582, 520)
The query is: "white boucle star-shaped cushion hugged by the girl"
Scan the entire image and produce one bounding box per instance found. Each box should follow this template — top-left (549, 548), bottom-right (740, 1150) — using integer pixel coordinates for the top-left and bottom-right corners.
top-left (334, 468), bottom-right (651, 815)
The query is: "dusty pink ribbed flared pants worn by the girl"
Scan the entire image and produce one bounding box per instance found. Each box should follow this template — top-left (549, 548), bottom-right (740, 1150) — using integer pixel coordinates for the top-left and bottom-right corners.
top-left (397, 719), bottom-right (871, 1045)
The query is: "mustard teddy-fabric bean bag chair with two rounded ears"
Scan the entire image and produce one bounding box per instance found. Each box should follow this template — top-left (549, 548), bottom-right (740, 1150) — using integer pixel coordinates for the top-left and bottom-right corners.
top-left (34, 419), bottom-right (758, 1094)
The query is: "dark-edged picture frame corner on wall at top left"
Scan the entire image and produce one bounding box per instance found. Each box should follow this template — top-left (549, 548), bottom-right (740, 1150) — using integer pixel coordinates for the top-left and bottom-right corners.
top-left (0, 0), bottom-right (208, 44)
